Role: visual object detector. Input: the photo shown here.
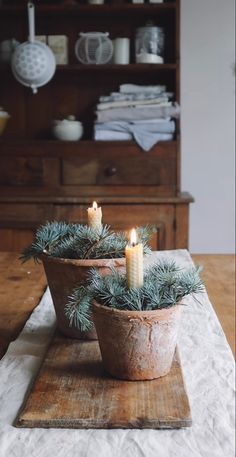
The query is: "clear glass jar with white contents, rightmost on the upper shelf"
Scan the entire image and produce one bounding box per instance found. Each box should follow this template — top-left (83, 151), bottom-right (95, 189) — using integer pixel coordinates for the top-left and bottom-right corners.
top-left (135, 24), bottom-right (164, 63)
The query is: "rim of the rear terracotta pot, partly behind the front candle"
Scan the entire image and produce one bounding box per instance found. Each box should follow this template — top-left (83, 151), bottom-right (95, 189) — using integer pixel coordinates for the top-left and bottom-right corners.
top-left (39, 254), bottom-right (125, 267)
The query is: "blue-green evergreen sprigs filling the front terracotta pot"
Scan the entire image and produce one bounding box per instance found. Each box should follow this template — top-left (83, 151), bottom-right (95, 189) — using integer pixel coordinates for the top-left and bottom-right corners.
top-left (66, 260), bottom-right (204, 328)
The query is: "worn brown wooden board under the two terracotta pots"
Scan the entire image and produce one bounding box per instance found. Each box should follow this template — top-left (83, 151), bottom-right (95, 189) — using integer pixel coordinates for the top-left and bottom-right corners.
top-left (15, 334), bottom-right (192, 429)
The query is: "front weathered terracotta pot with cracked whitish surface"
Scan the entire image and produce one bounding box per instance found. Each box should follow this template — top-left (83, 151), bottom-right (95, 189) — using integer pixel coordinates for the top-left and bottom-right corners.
top-left (93, 302), bottom-right (182, 380)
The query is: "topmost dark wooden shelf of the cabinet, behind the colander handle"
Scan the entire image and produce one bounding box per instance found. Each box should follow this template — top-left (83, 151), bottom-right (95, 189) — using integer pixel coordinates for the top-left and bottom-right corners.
top-left (0, 2), bottom-right (176, 16)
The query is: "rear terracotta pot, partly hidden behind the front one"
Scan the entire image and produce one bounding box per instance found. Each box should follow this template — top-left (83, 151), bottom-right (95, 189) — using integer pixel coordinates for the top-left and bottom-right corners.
top-left (41, 255), bottom-right (125, 339)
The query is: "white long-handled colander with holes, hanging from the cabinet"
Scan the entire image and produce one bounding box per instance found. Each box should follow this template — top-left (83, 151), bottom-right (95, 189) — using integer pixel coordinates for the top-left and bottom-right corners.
top-left (11, 3), bottom-right (56, 94)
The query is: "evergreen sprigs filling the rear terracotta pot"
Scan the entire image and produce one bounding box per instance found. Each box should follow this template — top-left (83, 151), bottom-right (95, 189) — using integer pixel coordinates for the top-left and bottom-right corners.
top-left (20, 221), bottom-right (151, 262)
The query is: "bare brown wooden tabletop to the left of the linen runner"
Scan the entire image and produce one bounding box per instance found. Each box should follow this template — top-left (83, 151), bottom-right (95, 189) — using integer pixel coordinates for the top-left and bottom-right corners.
top-left (0, 252), bottom-right (46, 358)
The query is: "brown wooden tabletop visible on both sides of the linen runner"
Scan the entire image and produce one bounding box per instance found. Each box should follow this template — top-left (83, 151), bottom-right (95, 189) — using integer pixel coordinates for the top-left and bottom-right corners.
top-left (0, 252), bottom-right (235, 357)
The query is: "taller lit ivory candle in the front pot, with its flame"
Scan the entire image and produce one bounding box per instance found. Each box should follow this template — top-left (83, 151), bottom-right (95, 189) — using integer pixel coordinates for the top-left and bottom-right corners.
top-left (125, 229), bottom-right (143, 289)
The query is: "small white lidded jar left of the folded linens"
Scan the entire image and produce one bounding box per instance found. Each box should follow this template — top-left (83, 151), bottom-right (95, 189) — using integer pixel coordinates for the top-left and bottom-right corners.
top-left (52, 116), bottom-right (83, 141)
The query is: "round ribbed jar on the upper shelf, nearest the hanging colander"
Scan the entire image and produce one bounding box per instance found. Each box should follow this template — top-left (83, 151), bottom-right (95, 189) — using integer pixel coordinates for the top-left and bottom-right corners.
top-left (75, 32), bottom-right (113, 64)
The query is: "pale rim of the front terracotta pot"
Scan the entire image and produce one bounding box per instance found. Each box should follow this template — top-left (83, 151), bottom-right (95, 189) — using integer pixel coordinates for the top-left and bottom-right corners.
top-left (92, 300), bottom-right (182, 320)
